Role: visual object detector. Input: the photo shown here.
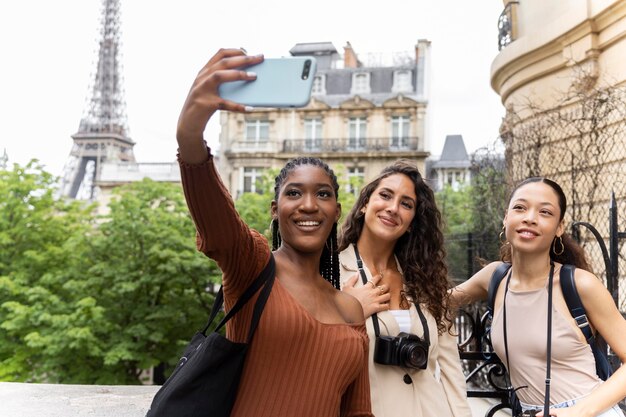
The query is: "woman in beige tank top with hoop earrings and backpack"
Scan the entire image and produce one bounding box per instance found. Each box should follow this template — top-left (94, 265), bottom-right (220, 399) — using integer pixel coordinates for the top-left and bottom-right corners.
top-left (453, 177), bottom-right (626, 417)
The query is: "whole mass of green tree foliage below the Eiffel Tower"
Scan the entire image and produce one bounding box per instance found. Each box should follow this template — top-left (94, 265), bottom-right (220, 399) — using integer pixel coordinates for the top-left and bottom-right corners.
top-left (0, 162), bottom-right (219, 384)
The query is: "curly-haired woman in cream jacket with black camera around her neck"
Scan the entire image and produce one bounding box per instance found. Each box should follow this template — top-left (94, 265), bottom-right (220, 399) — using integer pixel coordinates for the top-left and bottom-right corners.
top-left (339, 161), bottom-right (471, 417)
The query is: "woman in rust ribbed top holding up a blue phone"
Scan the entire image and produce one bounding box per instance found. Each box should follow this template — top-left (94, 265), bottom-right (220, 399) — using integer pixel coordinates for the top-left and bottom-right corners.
top-left (177, 49), bottom-right (372, 417)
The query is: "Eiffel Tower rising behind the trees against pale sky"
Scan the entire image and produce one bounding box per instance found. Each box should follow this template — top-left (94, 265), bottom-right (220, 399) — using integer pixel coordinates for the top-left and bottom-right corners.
top-left (60, 0), bottom-right (135, 200)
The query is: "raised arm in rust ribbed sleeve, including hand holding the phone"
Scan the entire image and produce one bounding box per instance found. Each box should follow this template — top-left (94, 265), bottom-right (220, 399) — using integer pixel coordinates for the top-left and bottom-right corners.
top-left (176, 49), bottom-right (269, 296)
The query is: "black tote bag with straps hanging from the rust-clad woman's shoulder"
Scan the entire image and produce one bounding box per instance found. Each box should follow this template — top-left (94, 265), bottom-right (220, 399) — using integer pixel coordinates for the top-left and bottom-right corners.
top-left (146, 255), bottom-right (276, 417)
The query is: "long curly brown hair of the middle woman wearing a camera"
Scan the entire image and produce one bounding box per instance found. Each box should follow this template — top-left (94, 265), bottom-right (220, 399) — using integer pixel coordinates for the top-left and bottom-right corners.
top-left (339, 160), bottom-right (453, 334)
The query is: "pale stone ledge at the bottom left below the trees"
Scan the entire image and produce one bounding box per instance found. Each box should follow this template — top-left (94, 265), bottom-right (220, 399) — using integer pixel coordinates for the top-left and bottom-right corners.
top-left (0, 382), bottom-right (159, 417)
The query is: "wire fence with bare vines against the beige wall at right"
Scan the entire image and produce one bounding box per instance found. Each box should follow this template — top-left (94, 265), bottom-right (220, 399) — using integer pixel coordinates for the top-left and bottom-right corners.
top-left (503, 83), bottom-right (626, 312)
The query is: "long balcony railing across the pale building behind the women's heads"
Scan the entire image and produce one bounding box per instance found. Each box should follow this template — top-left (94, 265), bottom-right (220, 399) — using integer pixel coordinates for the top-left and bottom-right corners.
top-left (283, 136), bottom-right (422, 153)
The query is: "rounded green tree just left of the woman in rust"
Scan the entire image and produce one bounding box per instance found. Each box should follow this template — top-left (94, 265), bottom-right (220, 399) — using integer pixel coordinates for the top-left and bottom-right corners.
top-left (83, 179), bottom-right (219, 383)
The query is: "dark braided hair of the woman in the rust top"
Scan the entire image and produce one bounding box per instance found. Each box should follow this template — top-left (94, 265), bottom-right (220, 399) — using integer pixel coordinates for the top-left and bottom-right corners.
top-left (272, 157), bottom-right (340, 289)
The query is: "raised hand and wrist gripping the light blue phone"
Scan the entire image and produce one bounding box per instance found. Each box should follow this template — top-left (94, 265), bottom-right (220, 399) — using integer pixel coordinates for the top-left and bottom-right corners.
top-left (176, 49), bottom-right (263, 164)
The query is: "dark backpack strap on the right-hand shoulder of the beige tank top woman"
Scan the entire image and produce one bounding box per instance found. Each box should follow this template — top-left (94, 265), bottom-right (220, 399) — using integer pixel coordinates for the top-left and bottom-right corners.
top-left (560, 265), bottom-right (612, 381)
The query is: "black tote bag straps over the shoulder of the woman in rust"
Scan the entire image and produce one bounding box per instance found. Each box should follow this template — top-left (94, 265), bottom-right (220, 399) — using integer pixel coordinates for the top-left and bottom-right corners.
top-left (202, 253), bottom-right (276, 342)
